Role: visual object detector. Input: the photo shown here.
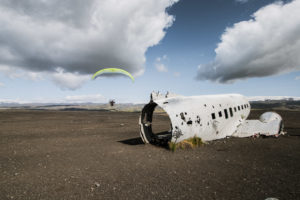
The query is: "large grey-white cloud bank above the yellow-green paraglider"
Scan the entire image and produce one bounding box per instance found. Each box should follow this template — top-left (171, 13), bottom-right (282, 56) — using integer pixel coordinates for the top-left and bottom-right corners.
top-left (0, 0), bottom-right (178, 89)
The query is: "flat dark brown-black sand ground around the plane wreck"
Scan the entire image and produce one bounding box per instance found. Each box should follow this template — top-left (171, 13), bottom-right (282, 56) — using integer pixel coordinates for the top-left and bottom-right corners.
top-left (0, 110), bottom-right (300, 200)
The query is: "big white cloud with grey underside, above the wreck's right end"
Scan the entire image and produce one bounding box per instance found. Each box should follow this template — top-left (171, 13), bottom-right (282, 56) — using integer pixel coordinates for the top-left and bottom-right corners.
top-left (197, 0), bottom-right (300, 83)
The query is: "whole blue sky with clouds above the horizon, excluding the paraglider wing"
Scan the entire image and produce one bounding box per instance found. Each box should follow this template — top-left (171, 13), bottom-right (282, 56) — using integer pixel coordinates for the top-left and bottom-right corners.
top-left (0, 0), bottom-right (300, 103)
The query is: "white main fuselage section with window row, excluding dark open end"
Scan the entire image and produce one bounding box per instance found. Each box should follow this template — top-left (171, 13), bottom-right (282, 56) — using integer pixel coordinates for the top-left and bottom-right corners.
top-left (154, 94), bottom-right (250, 142)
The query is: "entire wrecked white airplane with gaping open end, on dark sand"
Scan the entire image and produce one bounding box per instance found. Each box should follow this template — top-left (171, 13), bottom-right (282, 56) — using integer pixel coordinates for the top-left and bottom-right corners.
top-left (139, 92), bottom-right (283, 144)
